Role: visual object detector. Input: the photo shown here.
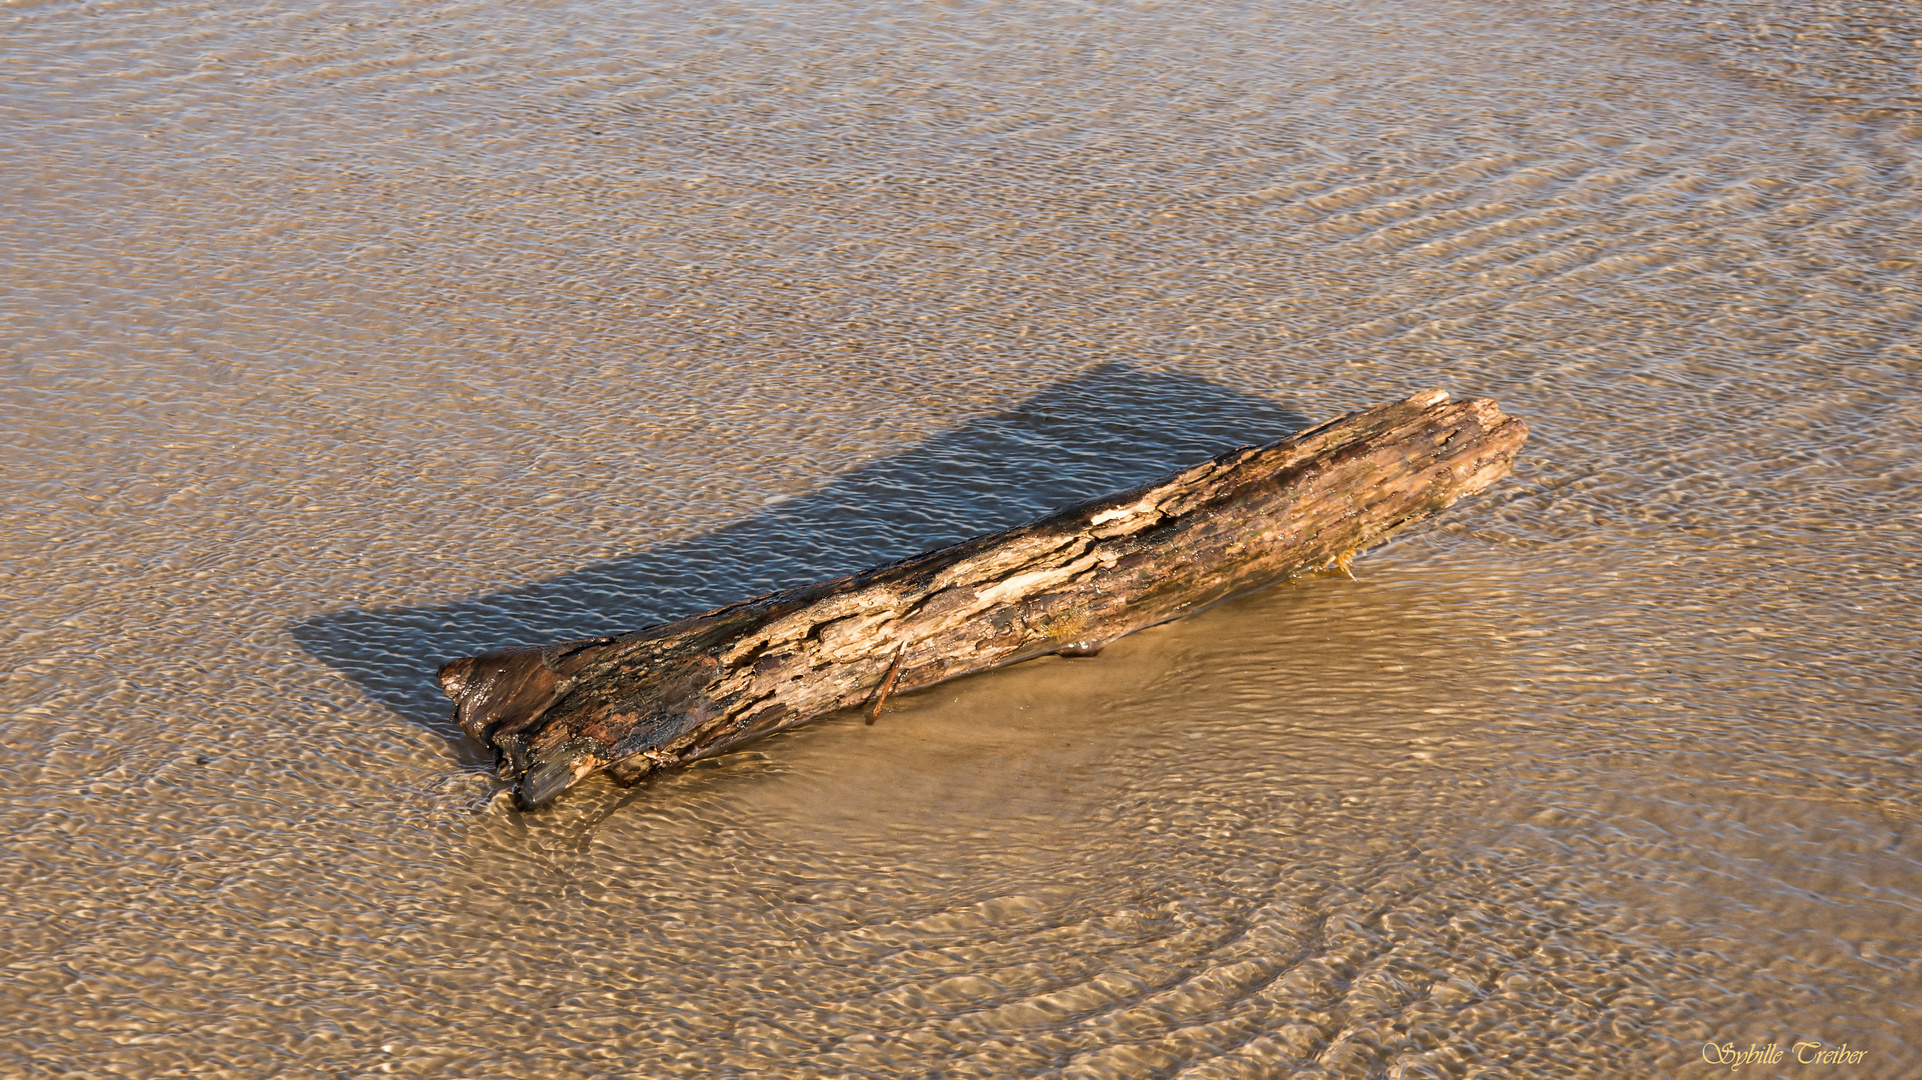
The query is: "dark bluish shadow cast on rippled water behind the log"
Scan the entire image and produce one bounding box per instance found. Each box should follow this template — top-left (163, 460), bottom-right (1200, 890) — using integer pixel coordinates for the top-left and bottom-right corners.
top-left (292, 363), bottom-right (1307, 749)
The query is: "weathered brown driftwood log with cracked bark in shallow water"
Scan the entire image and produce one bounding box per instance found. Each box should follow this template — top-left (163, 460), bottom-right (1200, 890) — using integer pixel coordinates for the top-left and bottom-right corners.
top-left (440, 390), bottom-right (1528, 805)
